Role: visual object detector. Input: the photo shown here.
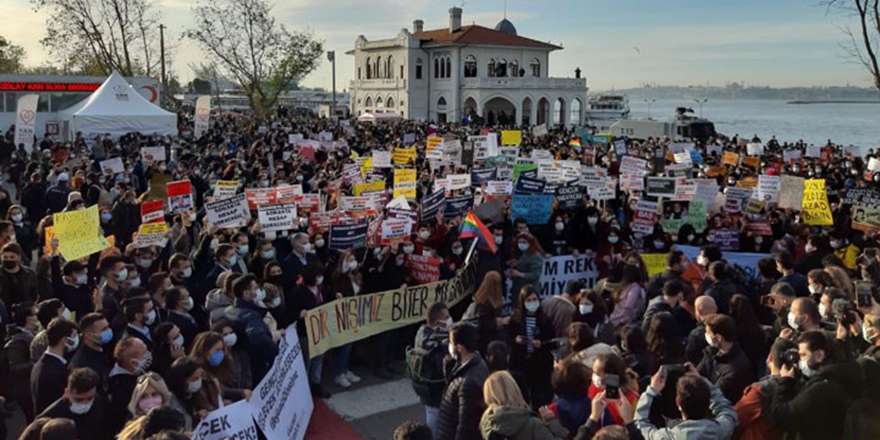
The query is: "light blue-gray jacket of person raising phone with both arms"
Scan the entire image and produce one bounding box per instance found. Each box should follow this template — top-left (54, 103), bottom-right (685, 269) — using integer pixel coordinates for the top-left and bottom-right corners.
top-left (635, 378), bottom-right (738, 440)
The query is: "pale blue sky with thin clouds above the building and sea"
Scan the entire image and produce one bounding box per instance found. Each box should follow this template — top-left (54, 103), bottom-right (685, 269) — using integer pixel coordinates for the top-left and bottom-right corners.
top-left (0, 0), bottom-right (871, 90)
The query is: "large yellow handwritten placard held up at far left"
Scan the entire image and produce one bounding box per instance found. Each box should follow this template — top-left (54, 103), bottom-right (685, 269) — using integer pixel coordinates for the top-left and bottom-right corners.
top-left (53, 205), bottom-right (110, 261)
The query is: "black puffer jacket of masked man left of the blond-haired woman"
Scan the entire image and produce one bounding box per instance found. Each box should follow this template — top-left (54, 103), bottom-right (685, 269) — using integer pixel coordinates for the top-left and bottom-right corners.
top-left (436, 353), bottom-right (489, 440)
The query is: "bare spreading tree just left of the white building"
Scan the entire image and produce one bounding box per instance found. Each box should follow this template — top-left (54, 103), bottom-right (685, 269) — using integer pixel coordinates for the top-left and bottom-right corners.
top-left (186, 0), bottom-right (324, 116)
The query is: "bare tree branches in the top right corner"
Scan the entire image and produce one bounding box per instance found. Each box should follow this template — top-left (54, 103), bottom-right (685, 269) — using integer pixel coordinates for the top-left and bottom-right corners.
top-left (823, 0), bottom-right (880, 90)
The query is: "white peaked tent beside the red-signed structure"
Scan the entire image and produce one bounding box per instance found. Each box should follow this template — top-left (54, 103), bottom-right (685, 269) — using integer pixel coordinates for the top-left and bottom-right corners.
top-left (58, 71), bottom-right (177, 139)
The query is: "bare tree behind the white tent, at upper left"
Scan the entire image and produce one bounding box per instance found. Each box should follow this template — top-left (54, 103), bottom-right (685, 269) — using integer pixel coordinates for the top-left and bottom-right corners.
top-left (31, 0), bottom-right (167, 76)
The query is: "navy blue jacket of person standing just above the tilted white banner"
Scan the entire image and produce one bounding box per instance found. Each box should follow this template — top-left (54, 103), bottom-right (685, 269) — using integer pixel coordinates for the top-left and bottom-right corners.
top-left (226, 299), bottom-right (278, 384)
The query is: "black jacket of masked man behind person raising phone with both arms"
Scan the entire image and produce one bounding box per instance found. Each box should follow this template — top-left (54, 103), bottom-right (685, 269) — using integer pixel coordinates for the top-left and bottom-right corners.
top-left (697, 345), bottom-right (755, 405)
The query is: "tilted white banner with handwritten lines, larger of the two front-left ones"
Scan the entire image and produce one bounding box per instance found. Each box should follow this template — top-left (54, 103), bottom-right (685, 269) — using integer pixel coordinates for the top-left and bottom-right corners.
top-left (248, 326), bottom-right (315, 440)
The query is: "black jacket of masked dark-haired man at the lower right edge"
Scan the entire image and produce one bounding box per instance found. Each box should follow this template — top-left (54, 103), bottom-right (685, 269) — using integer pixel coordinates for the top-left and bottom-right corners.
top-left (771, 361), bottom-right (864, 440)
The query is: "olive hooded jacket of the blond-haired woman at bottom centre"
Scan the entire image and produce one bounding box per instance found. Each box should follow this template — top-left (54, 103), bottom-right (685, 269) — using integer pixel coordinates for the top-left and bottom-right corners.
top-left (480, 406), bottom-right (568, 440)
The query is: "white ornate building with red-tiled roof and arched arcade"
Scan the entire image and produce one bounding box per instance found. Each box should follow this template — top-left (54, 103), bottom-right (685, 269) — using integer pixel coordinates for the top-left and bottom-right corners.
top-left (348, 7), bottom-right (587, 125)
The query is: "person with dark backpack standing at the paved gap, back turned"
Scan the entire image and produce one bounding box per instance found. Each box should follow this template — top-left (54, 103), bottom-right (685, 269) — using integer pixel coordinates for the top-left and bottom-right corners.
top-left (407, 302), bottom-right (452, 437)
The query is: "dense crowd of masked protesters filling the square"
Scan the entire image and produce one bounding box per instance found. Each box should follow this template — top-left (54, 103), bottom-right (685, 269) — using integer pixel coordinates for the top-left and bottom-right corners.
top-left (0, 106), bottom-right (880, 440)
